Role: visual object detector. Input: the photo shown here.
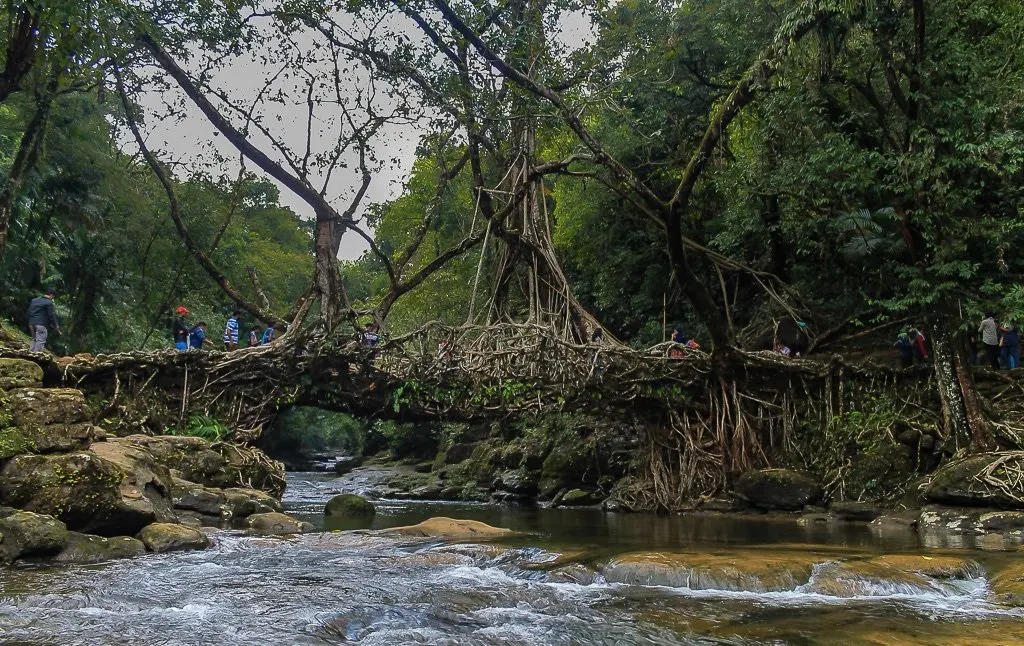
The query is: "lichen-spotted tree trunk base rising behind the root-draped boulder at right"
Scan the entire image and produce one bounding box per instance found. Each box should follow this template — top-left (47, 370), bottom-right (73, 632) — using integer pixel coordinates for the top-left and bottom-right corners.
top-left (932, 326), bottom-right (994, 451)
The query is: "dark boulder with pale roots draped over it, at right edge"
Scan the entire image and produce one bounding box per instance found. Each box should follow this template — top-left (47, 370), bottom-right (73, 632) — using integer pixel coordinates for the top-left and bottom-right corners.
top-left (925, 451), bottom-right (1024, 509)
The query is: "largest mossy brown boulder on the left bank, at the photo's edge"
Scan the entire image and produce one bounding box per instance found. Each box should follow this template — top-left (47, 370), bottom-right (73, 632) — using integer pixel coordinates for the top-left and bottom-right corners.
top-left (0, 442), bottom-right (174, 535)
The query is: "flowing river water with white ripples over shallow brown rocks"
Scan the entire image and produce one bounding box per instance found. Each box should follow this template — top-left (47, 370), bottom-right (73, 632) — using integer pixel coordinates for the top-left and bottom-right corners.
top-left (0, 473), bottom-right (1024, 646)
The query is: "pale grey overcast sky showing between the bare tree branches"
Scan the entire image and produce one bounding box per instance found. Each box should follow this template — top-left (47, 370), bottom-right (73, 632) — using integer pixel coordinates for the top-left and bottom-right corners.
top-left (129, 9), bottom-right (591, 259)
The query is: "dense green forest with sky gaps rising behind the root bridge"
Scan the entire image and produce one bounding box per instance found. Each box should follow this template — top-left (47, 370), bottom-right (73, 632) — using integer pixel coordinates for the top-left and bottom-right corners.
top-left (0, 0), bottom-right (1024, 364)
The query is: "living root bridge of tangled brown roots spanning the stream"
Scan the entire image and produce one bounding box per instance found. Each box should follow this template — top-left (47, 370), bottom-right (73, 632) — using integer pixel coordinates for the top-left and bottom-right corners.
top-left (8, 325), bottom-right (1024, 509)
